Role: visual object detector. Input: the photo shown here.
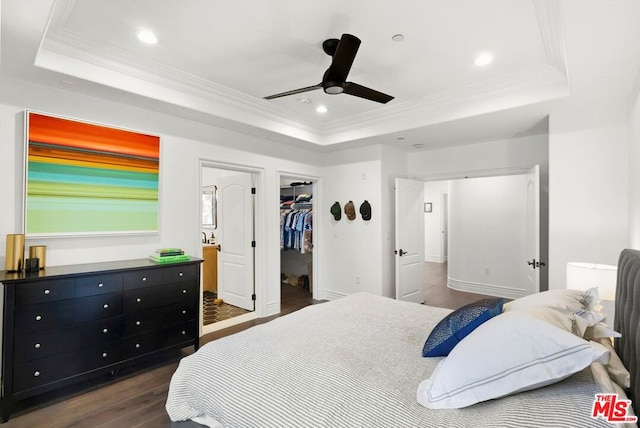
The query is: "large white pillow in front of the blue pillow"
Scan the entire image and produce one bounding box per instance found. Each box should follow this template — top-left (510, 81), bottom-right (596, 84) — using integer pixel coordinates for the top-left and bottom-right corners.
top-left (417, 311), bottom-right (609, 409)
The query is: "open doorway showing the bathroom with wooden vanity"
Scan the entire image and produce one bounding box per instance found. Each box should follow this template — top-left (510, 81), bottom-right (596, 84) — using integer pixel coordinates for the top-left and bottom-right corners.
top-left (200, 162), bottom-right (256, 333)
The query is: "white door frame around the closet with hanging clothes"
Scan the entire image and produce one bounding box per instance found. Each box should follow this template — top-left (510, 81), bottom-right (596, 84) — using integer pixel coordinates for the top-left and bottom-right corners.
top-left (276, 170), bottom-right (324, 306)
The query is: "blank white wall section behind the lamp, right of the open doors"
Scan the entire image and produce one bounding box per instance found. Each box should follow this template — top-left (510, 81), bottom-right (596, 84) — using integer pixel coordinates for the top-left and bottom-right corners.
top-left (549, 123), bottom-right (629, 289)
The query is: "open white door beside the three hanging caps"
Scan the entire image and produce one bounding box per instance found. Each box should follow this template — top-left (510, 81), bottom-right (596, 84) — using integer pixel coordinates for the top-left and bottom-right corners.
top-left (395, 178), bottom-right (425, 303)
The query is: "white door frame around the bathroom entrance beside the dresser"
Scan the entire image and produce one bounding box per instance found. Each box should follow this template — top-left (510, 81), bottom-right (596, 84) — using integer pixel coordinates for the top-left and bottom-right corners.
top-left (195, 158), bottom-right (268, 336)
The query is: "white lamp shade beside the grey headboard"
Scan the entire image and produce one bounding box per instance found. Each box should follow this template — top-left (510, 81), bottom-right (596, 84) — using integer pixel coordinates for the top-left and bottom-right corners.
top-left (567, 262), bottom-right (618, 300)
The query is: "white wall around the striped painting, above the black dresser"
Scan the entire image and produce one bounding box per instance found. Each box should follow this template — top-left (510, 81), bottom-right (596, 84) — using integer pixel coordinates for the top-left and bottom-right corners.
top-left (0, 79), bottom-right (322, 316)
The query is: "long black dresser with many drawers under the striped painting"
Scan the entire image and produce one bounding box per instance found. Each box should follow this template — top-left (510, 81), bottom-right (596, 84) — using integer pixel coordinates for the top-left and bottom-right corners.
top-left (0, 258), bottom-right (202, 422)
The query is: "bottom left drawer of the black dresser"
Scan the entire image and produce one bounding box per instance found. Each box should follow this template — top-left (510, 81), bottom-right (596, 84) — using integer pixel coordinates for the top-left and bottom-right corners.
top-left (13, 342), bottom-right (122, 392)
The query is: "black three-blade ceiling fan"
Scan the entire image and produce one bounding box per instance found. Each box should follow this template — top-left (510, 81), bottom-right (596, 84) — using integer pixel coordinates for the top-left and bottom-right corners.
top-left (264, 34), bottom-right (393, 104)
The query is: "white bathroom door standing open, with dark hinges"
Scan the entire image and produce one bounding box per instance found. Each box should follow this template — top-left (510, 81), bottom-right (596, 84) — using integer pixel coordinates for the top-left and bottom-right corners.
top-left (217, 173), bottom-right (254, 311)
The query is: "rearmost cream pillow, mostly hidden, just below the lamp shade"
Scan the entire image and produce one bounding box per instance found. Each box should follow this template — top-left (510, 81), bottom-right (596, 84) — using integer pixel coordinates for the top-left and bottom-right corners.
top-left (504, 287), bottom-right (598, 312)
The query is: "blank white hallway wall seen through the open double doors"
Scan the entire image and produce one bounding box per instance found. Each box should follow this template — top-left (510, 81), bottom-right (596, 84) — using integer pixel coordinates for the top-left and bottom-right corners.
top-left (448, 175), bottom-right (537, 298)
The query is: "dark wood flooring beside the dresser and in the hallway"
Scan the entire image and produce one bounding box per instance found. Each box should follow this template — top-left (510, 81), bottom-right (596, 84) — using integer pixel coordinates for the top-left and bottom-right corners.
top-left (0, 270), bottom-right (485, 428)
